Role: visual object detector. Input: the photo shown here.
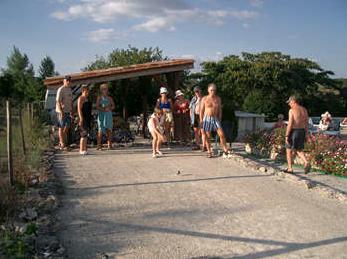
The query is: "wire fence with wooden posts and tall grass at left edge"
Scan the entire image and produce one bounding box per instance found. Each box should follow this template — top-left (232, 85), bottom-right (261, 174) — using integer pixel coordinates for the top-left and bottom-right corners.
top-left (0, 99), bottom-right (49, 185)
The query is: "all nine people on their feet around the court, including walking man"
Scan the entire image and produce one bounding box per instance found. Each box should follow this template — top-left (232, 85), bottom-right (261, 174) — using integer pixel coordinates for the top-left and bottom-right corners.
top-left (56, 76), bottom-right (316, 173)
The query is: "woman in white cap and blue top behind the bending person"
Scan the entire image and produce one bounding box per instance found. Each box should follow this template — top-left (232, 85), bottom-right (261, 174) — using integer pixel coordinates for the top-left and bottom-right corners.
top-left (155, 87), bottom-right (173, 144)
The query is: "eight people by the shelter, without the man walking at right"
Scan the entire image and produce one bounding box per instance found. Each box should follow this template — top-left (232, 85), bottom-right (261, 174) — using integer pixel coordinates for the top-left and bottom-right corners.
top-left (55, 76), bottom-right (230, 157)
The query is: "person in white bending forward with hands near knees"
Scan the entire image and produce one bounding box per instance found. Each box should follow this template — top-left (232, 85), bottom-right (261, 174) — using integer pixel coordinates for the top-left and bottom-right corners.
top-left (148, 108), bottom-right (165, 158)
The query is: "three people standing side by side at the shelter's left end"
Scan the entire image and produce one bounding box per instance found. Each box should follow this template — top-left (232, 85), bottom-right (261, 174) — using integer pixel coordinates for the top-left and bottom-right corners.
top-left (56, 76), bottom-right (115, 155)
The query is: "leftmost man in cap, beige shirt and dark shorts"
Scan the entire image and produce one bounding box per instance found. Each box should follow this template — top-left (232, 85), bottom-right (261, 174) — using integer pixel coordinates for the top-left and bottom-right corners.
top-left (55, 76), bottom-right (73, 149)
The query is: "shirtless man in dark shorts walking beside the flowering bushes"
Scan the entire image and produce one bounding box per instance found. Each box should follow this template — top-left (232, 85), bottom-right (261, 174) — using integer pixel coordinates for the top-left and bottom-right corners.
top-left (285, 96), bottom-right (311, 173)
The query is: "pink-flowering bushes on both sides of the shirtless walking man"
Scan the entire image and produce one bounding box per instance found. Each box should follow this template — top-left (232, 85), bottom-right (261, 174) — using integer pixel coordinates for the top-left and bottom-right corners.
top-left (244, 131), bottom-right (347, 176)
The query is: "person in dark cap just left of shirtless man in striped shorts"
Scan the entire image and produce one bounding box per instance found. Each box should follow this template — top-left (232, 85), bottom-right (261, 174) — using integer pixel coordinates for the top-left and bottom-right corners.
top-left (189, 86), bottom-right (204, 150)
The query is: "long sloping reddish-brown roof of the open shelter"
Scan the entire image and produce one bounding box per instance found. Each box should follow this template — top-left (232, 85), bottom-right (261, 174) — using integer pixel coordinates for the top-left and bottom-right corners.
top-left (44, 59), bottom-right (194, 87)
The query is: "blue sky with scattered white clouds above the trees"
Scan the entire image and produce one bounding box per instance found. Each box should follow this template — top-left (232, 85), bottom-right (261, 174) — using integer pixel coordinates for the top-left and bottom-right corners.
top-left (0, 0), bottom-right (347, 78)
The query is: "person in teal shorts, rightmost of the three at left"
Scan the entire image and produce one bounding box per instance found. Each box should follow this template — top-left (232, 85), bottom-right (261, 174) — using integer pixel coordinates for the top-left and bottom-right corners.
top-left (96, 84), bottom-right (115, 150)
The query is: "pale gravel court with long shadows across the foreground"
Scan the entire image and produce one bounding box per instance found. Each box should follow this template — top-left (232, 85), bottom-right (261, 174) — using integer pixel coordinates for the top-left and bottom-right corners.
top-left (55, 149), bottom-right (347, 259)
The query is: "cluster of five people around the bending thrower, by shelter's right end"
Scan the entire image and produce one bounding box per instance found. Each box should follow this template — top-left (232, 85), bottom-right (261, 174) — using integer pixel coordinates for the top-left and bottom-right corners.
top-left (148, 83), bottom-right (231, 158)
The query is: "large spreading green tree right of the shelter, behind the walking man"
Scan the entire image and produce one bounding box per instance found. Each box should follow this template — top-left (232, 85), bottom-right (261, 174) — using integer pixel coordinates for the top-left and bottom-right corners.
top-left (193, 52), bottom-right (338, 119)
